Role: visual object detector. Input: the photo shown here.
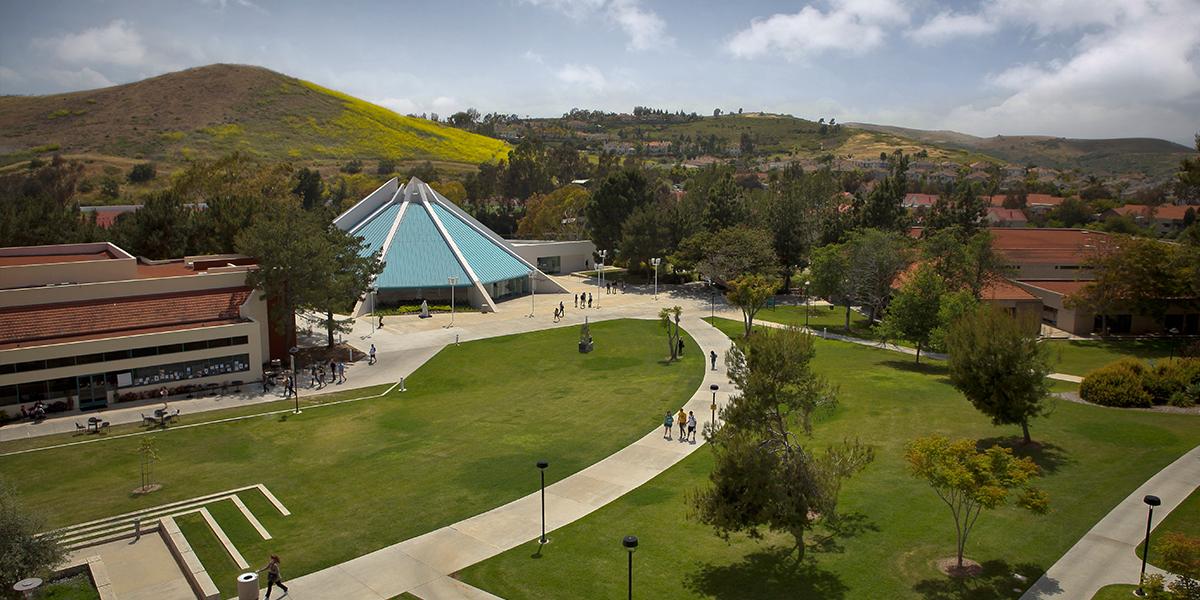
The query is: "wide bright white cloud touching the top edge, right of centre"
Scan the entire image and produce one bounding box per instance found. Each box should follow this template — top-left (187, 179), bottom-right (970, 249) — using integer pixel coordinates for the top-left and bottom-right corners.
top-left (725, 0), bottom-right (908, 60)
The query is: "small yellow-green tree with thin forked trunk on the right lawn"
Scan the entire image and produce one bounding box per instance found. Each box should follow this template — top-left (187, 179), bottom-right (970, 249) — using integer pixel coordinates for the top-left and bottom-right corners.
top-left (905, 436), bottom-right (1049, 570)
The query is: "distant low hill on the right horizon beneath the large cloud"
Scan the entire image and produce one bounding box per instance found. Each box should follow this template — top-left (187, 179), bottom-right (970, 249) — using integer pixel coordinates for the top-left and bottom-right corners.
top-left (851, 124), bottom-right (1195, 179)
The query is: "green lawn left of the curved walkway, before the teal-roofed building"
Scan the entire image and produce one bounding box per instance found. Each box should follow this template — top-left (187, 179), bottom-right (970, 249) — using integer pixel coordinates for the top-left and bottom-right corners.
top-left (0, 319), bottom-right (704, 595)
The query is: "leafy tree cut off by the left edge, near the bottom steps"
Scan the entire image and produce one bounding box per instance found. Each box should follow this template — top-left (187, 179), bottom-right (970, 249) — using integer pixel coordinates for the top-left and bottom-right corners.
top-left (0, 481), bottom-right (66, 590)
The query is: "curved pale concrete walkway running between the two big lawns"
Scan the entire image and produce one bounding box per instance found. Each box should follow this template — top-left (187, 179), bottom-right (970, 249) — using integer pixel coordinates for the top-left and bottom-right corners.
top-left (277, 317), bottom-right (733, 600)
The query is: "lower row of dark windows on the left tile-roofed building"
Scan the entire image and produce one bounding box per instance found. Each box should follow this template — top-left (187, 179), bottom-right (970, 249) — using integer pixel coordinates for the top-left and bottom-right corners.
top-left (0, 354), bottom-right (250, 408)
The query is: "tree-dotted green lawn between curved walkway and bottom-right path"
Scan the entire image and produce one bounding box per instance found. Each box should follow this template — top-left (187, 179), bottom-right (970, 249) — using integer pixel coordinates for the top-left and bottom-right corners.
top-left (461, 320), bottom-right (1200, 600)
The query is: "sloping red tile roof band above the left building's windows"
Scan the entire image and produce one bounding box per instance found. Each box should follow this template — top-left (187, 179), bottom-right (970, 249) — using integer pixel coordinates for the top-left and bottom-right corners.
top-left (0, 288), bottom-right (252, 348)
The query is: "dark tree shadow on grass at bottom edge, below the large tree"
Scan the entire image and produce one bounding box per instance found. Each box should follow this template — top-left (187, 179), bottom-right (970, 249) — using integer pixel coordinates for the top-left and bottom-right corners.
top-left (684, 547), bottom-right (847, 600)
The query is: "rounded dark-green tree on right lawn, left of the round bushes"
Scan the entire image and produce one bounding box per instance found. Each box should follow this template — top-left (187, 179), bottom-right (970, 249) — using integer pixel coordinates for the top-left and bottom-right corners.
top-left (946, 306), bottom-right (1052, 444)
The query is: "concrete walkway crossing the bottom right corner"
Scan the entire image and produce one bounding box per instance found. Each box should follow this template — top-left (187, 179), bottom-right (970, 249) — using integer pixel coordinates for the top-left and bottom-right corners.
top-left (1021, 446), bottom-right (1200, 600)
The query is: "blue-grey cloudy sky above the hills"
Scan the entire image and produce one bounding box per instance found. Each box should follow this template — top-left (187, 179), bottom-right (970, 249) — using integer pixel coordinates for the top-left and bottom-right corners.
top-left (0, 0), bottom-right (1200, 145)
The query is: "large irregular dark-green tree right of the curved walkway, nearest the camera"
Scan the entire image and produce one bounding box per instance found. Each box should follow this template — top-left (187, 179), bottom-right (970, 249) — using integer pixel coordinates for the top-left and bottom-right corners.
top-left (689, 328), bottom-right (874, 559)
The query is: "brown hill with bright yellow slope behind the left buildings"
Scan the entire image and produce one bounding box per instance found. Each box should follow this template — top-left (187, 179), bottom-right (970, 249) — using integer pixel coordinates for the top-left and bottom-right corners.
top-left (0, 65), bottom-right (509, 169)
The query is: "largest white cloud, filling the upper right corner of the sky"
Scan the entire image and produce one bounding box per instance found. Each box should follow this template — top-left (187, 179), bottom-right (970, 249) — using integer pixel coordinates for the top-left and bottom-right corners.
top-left (944, 0), bottom-right (1200, 139)
